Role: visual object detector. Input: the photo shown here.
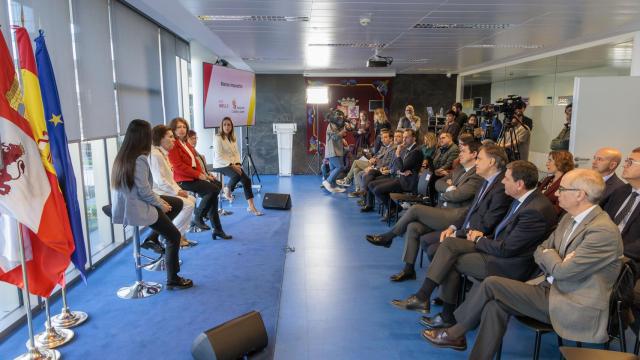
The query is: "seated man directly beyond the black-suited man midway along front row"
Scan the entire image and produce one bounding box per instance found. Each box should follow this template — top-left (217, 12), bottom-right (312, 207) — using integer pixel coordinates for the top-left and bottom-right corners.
top-left (350, 130), bottom-right (402, 197)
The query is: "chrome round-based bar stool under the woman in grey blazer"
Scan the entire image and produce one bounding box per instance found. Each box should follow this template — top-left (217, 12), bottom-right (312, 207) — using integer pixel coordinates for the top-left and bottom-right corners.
top-left (102, 205), bottom-right (164, 299)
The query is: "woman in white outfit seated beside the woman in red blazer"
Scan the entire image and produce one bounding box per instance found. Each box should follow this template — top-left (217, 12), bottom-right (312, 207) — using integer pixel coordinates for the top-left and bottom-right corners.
top-left (149, 125), bottom-right (196, 247)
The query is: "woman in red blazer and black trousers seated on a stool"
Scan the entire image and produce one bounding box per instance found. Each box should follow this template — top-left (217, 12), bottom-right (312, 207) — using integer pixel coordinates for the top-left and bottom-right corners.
top-left (169, 118), bottom-right (231, 240)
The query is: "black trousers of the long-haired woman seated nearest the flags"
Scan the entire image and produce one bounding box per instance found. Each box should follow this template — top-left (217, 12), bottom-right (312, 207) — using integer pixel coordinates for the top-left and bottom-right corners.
top-left (149, 195), bottom-right (183, 281)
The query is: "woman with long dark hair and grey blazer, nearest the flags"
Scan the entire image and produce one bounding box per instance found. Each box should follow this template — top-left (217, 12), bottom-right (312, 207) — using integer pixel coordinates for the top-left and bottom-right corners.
top-left (111, 119), bottom-right (193, 289)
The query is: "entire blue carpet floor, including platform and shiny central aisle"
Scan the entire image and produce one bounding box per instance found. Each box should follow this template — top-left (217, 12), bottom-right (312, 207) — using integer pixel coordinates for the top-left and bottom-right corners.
top-left (0, 176), bottom-right (635, 360)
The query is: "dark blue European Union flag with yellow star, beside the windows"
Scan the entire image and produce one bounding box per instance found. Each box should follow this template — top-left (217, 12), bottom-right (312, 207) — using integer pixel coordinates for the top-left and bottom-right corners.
top-left (35, 30), bottom-right (87, 281)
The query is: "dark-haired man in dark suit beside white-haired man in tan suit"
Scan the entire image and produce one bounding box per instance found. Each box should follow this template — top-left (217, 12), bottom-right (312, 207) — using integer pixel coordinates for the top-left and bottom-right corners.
top-left (392, 160), bottom-right (557, 318)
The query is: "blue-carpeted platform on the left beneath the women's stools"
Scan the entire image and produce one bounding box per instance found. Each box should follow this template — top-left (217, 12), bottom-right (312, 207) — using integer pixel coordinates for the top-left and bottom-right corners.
top-left (0, 176), bottom-right (291, 359)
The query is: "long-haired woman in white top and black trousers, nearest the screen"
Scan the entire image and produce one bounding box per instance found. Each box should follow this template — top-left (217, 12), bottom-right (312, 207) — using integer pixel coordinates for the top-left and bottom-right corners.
top-left (213, 117), bottom-right (262, 216)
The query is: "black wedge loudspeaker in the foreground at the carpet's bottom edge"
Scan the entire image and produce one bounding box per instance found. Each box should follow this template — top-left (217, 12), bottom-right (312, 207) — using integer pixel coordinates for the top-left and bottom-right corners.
top-left (191, 311), bottom-right (268, 360)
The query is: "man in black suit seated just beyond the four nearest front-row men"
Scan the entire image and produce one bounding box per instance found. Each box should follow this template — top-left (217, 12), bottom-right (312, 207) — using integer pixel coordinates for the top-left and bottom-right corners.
top-left (369, 129), bottom-right (422, 220)
